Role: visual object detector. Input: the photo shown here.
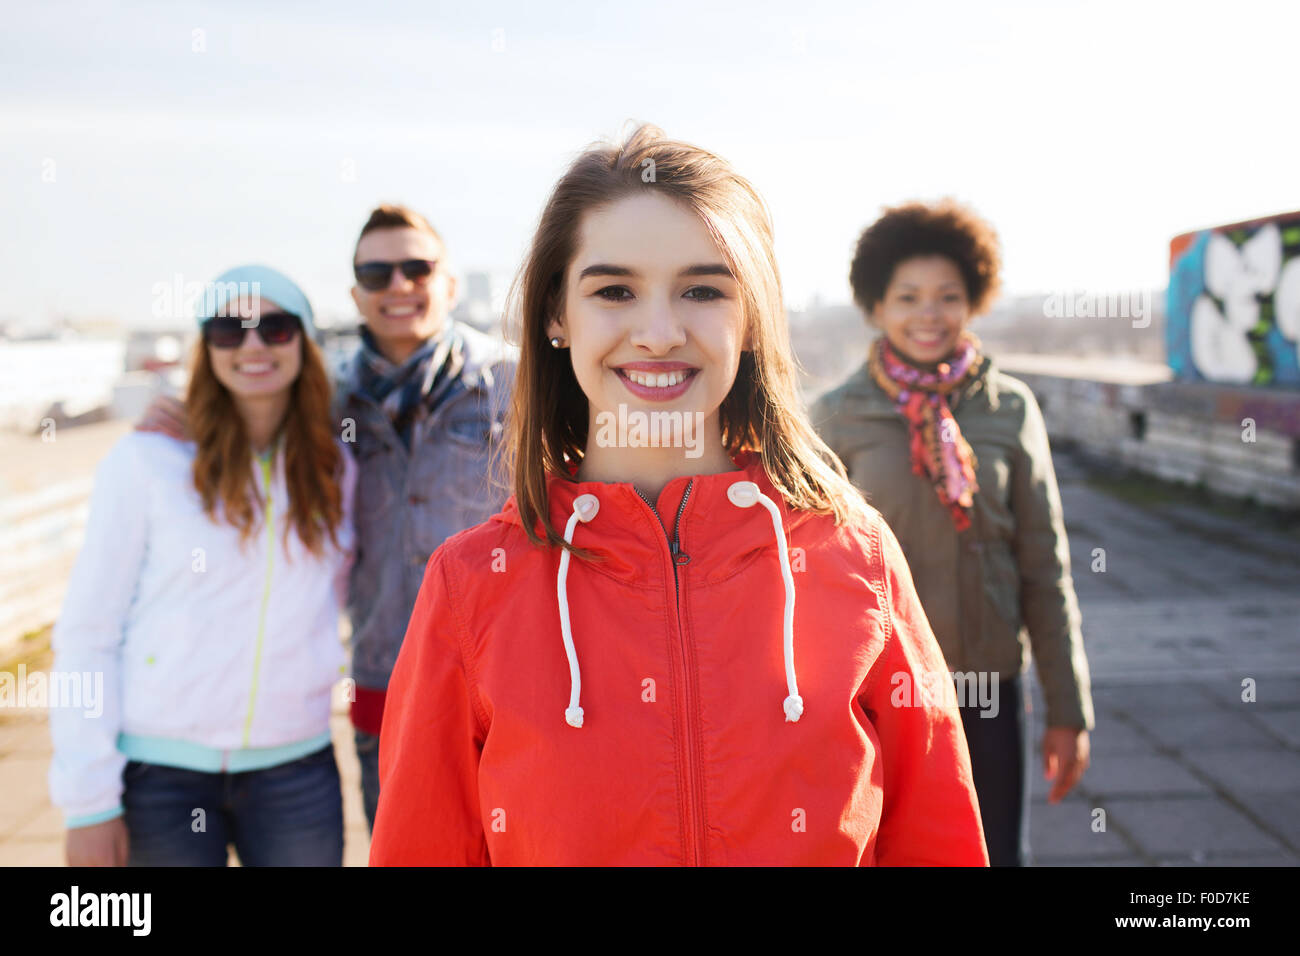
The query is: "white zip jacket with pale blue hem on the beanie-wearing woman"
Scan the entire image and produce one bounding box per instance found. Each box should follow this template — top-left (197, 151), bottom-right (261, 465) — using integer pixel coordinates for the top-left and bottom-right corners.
top-left (49, 432), bottom-right (356, 826)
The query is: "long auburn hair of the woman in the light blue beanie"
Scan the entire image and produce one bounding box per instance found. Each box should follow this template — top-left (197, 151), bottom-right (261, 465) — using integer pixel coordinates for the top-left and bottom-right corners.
top-left (185, 330), bottom-right (343, 557)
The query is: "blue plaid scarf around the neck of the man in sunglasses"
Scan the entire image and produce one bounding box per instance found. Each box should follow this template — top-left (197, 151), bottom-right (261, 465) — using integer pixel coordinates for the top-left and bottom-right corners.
top-left (358, 324), bottom-right (465, 449)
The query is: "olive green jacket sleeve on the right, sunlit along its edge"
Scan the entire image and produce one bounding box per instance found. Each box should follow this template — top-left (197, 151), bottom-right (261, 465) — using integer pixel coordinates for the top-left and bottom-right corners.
top-left (1011, 390), bottom-right (1093, 730)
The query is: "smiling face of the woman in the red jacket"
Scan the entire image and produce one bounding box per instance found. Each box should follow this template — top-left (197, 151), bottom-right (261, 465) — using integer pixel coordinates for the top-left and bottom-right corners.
top-left (547, 194), bottom-right (746, 470)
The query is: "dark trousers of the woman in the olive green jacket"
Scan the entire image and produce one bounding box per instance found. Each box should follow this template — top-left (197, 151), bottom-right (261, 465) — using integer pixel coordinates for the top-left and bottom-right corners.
top-left (958, 675), bottom-right (1030, 866)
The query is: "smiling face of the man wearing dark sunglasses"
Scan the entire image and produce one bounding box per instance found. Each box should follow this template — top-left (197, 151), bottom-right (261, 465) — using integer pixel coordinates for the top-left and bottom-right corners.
top-left (352, 228), bottom-right (456, 362)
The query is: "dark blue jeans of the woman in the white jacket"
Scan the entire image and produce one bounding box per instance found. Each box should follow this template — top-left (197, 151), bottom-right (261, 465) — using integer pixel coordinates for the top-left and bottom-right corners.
top-left (122, 747), bottom-right (343, 866)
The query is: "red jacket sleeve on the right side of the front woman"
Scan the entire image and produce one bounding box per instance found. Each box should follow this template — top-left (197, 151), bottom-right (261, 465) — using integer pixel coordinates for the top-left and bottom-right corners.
top-left (862, 520), bottom-right (988, 866)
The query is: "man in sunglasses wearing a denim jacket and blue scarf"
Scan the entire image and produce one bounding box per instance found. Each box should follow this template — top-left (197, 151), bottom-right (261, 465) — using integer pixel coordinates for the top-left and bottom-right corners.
top-left (138, 206), bottom-right (515, 829)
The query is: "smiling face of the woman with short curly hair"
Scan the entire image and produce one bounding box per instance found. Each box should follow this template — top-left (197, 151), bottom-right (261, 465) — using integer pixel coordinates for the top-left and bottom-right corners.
top-left (870, 255), bottom-right (971, 365)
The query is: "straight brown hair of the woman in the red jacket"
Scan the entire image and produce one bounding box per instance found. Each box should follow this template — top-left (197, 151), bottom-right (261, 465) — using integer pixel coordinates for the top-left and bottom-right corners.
top-left (504, 125), bottom-right (865, 557)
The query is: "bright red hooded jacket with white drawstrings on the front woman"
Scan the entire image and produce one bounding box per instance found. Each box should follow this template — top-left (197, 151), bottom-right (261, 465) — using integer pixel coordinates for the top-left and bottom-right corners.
top-left (371, 453), bottom-right (988, 865)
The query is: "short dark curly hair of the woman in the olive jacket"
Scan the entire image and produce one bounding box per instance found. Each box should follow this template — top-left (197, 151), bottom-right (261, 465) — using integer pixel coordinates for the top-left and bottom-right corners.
top-left (849, 199), bottom-right (1002, 315)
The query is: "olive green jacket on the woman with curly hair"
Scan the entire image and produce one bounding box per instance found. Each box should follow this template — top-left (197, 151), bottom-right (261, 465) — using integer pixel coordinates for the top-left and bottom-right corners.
top-left (813, 360), bottom-right (1093, 730)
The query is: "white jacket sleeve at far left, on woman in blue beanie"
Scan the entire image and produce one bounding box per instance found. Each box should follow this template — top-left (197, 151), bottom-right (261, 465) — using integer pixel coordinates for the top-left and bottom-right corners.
top-left (48, 436), bottom-right (150, 827)
